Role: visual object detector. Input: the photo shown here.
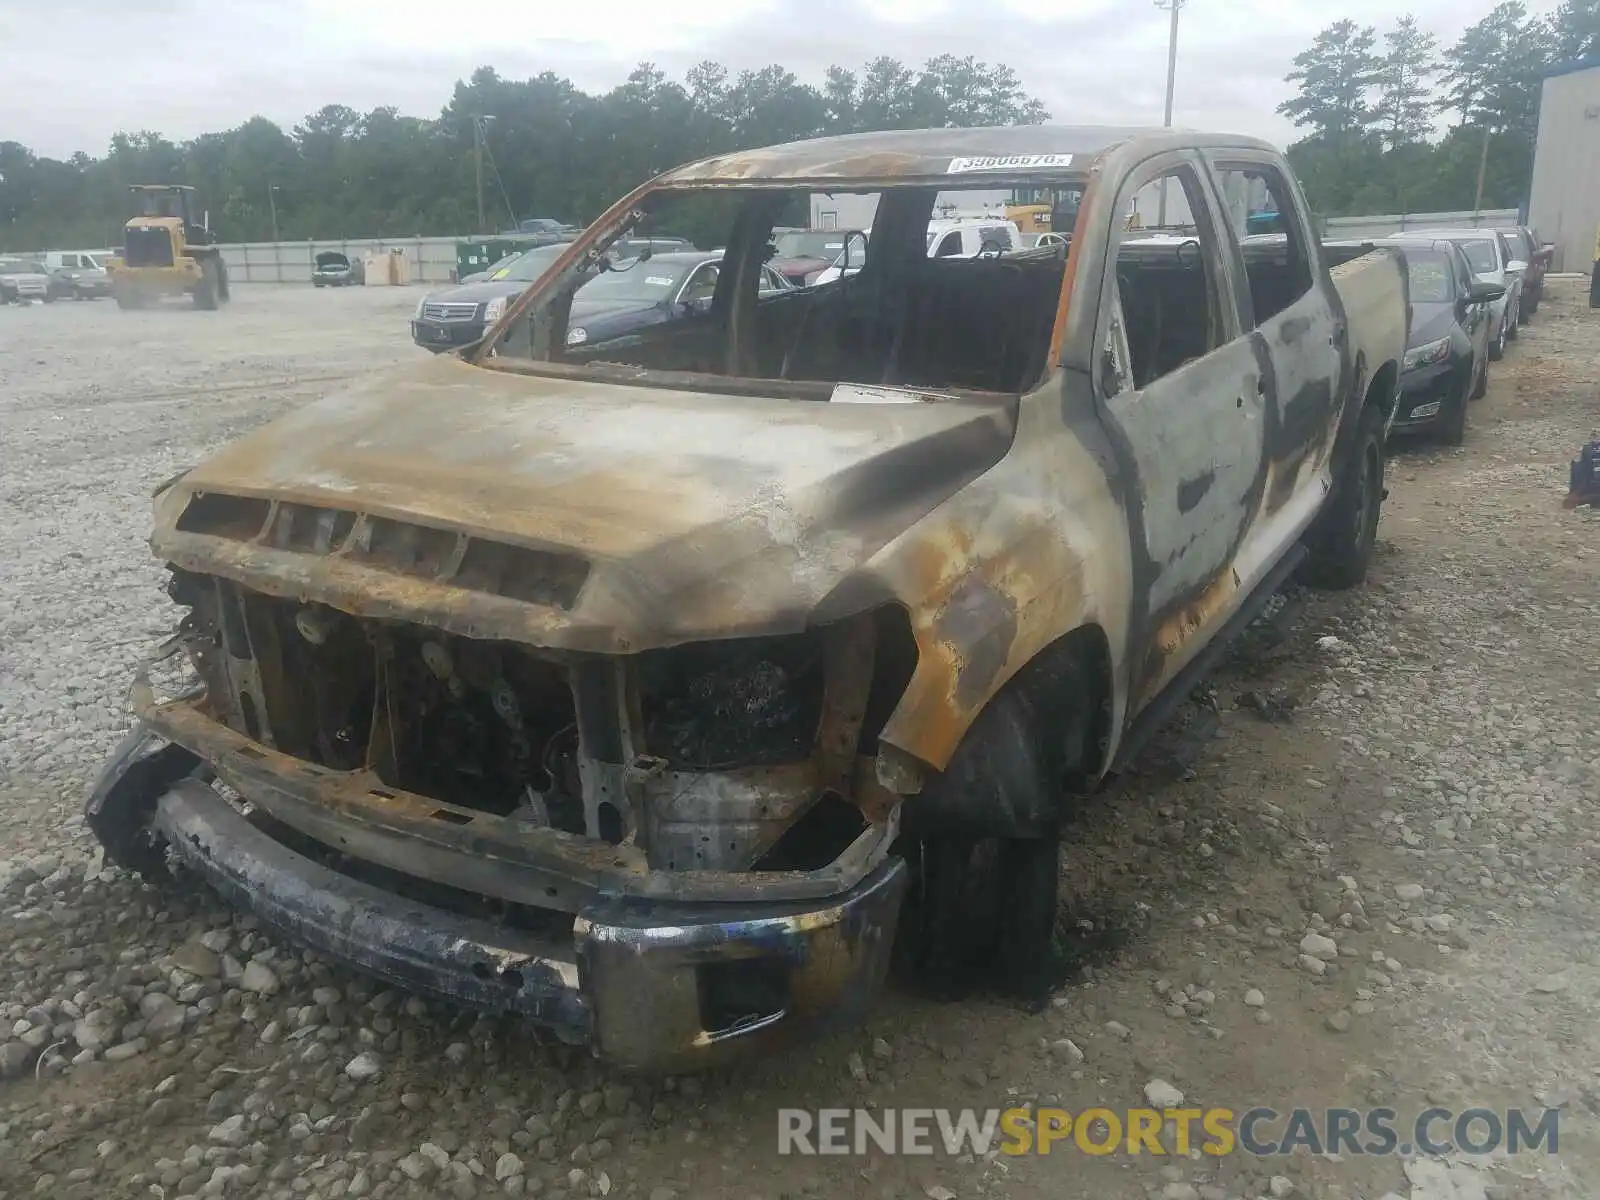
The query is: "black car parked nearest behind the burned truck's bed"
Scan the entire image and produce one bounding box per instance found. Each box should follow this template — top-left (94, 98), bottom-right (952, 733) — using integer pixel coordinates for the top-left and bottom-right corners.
top-left (1378, 237), bottom-right (1506, 445)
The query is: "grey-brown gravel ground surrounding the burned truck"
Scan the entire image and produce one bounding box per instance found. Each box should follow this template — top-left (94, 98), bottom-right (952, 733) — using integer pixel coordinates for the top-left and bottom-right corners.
top-left (0, 280), bottom-right (1600, 1200)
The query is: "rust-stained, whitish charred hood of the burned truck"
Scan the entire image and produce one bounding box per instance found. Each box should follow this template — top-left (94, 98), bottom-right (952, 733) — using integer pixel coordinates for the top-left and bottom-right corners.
top-left (152, 358), bottom-right (1014, 653)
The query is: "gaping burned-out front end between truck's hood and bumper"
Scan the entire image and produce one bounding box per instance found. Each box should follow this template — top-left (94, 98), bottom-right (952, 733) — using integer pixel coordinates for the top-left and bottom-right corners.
top-left (171, 563), bottom-right (915, 872)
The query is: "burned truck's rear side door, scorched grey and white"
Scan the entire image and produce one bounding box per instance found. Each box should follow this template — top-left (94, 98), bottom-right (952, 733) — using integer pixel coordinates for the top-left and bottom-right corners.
top-left (1202, 149), bottom-right (1344, 590)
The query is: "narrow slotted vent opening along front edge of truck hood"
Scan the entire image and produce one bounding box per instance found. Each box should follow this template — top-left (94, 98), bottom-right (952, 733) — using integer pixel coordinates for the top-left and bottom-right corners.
top-left (176, 491), bottom-right (589, 611)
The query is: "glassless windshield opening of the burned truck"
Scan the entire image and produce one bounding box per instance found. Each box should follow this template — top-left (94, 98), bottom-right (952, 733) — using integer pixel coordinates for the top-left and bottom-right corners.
top-left (486, 186), bottom-right (1067, 403)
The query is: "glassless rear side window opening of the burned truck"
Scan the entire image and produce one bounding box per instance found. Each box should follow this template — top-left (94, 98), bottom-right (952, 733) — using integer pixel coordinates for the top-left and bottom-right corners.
top-left (1218, 163), bottom-right (1317, 325)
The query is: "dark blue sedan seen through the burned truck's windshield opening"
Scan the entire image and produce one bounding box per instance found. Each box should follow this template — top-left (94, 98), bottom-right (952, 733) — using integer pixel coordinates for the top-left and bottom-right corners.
top-left (566, 250), bottom-right (794, 346)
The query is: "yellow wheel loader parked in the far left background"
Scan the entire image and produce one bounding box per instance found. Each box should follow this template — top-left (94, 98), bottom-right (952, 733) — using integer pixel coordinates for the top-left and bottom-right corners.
top-left (106, 184), bottom-right (229, 309)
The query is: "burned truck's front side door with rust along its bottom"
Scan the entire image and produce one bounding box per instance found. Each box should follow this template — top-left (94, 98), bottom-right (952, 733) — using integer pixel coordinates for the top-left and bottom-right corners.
top-left (1093, 150), bottom-right (1269, 712)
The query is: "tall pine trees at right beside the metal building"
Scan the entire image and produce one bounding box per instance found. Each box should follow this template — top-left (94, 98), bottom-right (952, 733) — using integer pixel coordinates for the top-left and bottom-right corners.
top-left (1278, 0), bottom-right (1600, 216)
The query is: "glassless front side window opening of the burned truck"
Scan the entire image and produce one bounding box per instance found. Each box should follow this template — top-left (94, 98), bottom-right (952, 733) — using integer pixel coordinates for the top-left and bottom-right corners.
top-left (1101, 168), bottom-right (1227, 390)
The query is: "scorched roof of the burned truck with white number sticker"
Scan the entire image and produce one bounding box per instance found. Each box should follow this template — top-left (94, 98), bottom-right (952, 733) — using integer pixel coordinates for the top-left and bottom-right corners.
top-left (658, 125), bottom-right (1274, 187)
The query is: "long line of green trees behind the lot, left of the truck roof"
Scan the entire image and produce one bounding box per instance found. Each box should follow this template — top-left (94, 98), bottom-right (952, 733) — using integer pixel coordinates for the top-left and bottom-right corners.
top-left (0, 54), bottom-right (1048, 250)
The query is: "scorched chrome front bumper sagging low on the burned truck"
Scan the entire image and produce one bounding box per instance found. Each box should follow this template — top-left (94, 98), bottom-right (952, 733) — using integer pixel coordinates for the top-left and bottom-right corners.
top-left (86, 730), bottom-right (907, 1070)
